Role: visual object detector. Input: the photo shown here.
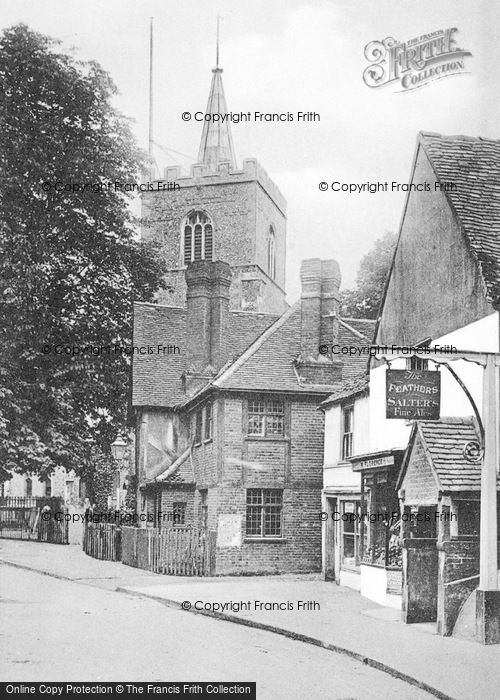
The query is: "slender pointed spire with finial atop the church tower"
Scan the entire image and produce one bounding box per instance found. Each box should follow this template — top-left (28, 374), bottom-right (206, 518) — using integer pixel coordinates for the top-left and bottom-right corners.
top-left (198, 17), bottom-right (236, 172)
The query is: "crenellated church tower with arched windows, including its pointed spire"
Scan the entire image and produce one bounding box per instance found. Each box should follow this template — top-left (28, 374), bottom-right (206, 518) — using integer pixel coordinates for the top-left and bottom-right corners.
top-left (142, 65), bottom-right (287, 314)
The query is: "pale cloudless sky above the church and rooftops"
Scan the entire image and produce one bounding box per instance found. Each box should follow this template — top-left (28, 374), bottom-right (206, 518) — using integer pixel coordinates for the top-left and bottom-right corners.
top-left (0, 0), bottom-right (500, 301)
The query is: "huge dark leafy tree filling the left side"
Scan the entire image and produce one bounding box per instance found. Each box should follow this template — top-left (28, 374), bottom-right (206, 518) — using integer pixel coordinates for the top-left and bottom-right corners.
top-left (0, 25), bottom-right (162, 478)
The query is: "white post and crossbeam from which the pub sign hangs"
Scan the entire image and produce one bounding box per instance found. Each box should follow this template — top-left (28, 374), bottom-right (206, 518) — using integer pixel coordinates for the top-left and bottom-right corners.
top-left (370, 346), bottom-right (500, 644)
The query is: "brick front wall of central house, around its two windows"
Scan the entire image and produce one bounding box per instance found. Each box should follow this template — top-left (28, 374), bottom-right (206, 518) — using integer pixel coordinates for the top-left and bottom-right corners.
top-left (209, 396), bottom-right (323, 574)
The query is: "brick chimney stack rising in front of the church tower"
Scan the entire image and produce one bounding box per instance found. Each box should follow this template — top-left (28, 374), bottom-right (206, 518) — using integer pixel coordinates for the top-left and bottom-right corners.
top-left (186, 260), bottom-right (232, 373)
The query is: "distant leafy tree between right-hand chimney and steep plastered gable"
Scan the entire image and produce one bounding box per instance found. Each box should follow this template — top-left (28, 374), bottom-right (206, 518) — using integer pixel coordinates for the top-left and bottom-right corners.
top-left (340, 231), bottom-right (397, 319)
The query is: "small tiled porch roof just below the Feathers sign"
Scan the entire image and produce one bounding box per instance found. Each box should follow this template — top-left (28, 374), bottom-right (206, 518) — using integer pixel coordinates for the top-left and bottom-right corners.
top-left (398, 418), bottom-right (496, 491)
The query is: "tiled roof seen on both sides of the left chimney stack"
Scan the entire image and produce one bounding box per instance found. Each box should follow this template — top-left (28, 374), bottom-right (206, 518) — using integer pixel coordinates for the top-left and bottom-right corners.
top-left (132, 303), bottom-right (277, 406)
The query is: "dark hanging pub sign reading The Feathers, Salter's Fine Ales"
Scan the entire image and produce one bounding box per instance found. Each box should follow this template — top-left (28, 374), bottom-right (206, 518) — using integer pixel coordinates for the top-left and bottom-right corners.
top-left (385, 369), bottom-right (441, 420)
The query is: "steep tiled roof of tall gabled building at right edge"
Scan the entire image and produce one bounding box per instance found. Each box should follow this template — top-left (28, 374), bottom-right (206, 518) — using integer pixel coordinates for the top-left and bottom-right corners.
top-left (420, 133), bottom-right (500, 303)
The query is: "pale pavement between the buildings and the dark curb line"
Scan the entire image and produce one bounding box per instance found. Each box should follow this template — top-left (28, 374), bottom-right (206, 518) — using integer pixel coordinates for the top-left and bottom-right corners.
top-left (0, 540), bottom-right (500, 700)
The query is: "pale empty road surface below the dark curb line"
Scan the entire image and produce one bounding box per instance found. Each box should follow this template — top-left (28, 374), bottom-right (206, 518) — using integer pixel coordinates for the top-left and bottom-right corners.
top-left (0, 565), bottom-right (430, 700)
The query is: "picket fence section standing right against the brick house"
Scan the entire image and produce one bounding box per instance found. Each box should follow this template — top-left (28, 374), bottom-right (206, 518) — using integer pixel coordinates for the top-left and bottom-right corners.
top-left (122, 526), bottom-right (215, 576)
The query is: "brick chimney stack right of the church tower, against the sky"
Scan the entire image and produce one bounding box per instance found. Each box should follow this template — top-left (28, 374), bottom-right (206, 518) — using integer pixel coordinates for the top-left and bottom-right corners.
top-left (300, 258), bottom-right (341, 362)
